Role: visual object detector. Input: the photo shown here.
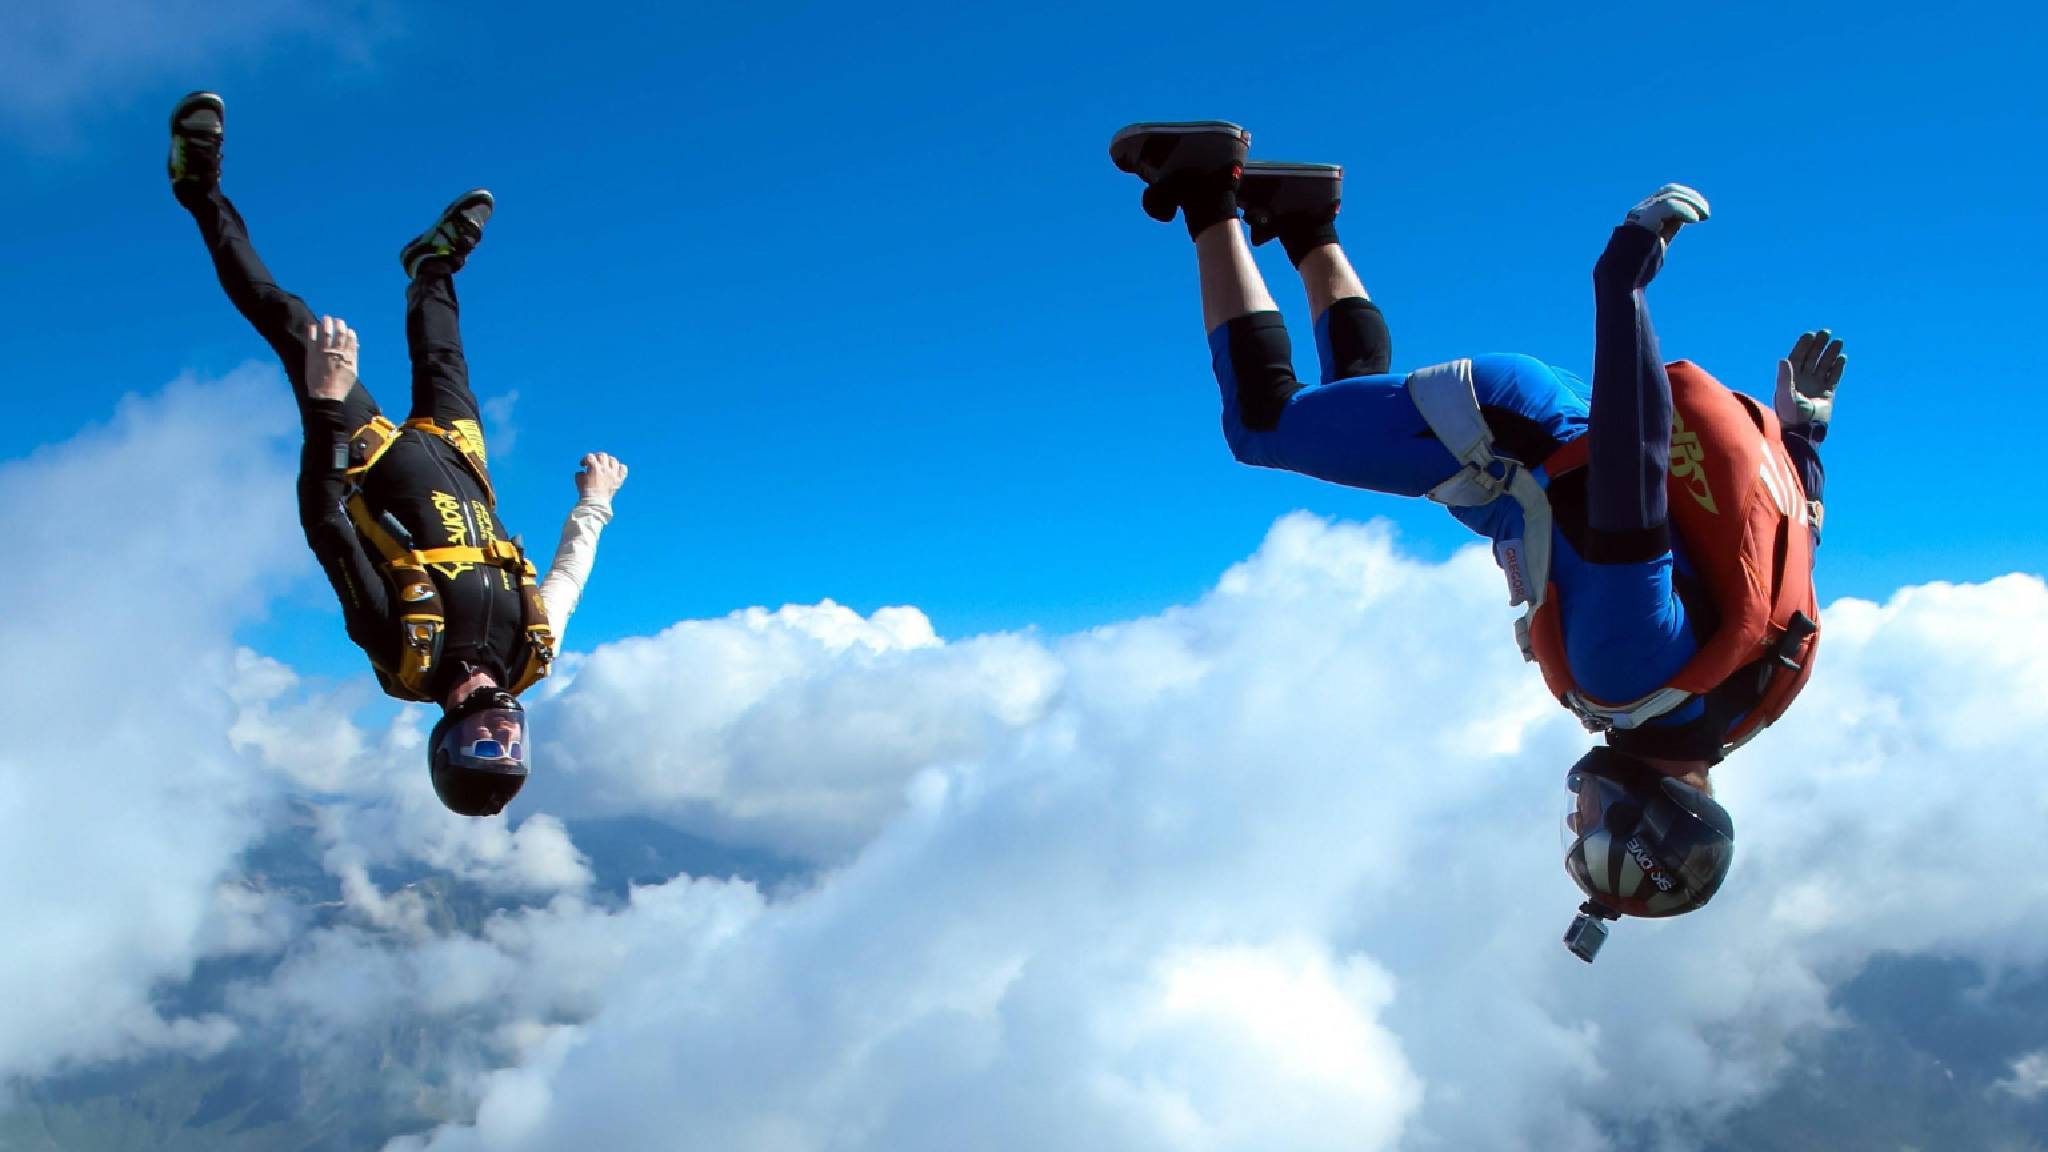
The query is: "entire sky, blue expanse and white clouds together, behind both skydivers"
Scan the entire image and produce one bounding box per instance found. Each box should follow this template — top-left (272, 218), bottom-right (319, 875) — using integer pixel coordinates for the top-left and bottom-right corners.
top-left (0, 0), bottom-right (2048, 1152)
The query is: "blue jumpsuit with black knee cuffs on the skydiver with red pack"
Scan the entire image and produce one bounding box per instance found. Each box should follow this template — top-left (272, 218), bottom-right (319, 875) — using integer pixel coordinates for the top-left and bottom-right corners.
top-left (1208, 223), bottom-right (1821, 758)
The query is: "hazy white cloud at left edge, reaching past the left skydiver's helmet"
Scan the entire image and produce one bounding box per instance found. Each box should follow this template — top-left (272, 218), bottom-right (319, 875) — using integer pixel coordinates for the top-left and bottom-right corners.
top-left (0, 369), bottom-right (590, 1080)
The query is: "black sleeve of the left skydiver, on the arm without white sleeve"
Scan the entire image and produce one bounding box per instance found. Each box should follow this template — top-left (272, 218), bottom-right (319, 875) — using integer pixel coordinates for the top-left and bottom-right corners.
top-left (299, 400), bottom-right (399, 668)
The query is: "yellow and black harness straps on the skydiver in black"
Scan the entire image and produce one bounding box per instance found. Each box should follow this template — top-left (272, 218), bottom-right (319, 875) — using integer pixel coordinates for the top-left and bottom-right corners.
top-left (342, 416), bottom-right (555, 701)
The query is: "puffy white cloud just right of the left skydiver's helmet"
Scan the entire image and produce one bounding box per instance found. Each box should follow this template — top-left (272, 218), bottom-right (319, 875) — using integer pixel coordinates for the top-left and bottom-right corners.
top-left (532, 601), bottom-right (1057, 859)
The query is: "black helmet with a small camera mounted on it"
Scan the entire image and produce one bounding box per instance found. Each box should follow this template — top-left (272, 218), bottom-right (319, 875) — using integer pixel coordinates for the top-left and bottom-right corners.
top-left (1565, 748), bottom-right (1735, 961)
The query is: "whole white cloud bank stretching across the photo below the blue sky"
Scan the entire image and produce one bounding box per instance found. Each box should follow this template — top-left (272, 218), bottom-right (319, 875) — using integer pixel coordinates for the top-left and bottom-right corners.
top-left (0, 373), bottom-right (2048, 1152)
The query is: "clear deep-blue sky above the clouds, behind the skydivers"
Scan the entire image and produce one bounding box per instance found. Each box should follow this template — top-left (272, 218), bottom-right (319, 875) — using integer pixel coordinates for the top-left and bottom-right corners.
top-left (0, 2), bottom-right (2048, 674)
